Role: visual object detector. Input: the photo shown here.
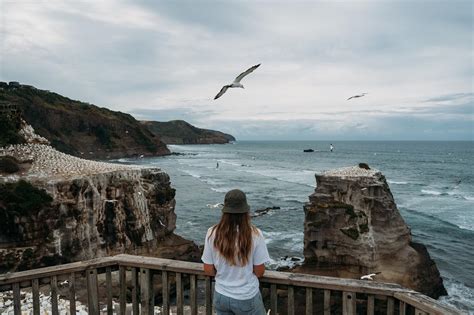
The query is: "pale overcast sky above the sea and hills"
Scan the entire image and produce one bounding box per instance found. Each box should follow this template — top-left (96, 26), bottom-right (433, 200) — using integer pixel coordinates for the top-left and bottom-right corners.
top-left (0, 0), bottom-right (474, 140)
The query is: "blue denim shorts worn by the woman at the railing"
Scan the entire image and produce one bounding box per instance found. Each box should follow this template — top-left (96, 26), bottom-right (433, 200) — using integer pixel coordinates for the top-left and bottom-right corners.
top-left (214, 291), bottom-right (265, 315)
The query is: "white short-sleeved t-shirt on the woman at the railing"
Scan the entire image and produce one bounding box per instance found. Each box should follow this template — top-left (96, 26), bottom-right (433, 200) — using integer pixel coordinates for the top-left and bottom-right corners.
top-left (201, 228), bottom-right (270, 300)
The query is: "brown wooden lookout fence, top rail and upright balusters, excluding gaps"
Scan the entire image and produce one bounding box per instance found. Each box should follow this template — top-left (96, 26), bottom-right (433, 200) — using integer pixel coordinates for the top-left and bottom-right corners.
top-left (0, 254), bottom-right (461, 315)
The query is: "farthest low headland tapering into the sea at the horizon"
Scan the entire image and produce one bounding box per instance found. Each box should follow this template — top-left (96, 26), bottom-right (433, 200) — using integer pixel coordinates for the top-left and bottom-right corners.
top-left (141, 120), bottom-right (235, 144)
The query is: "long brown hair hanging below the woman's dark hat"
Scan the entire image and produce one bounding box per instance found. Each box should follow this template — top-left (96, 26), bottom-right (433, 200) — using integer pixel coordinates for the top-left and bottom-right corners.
top-left (209, 212), bottom-right (258, 266)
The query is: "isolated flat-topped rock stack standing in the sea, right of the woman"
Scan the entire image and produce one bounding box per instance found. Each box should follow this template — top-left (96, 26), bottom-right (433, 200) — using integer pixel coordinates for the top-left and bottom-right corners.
top-left (295, 167), bottom-right (446, 298)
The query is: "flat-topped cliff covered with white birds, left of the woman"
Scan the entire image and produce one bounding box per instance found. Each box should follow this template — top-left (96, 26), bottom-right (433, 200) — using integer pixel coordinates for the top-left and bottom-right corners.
top-left (0, 145), bottom-right (199, 272)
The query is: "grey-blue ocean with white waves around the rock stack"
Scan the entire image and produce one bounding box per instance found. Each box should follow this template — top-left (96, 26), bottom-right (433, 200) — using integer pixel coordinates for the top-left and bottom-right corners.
top-left (121, 141), bottom-right (474, 313)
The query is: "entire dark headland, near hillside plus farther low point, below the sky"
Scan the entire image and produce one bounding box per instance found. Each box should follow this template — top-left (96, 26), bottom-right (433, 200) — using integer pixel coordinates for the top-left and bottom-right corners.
top-left (0, 81), bottom-right (235, 159)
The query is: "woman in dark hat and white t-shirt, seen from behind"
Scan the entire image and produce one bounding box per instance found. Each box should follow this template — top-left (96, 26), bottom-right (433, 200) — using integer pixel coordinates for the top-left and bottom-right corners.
top-left (201, 189), bottom-right (270, 315)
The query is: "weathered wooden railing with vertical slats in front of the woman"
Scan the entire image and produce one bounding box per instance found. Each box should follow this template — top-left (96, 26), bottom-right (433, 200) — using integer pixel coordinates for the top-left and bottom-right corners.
top-left (0, 255), bottom-right (461, 315)
